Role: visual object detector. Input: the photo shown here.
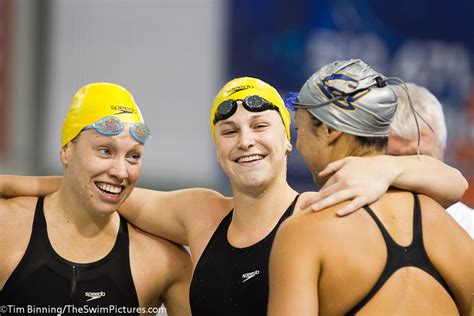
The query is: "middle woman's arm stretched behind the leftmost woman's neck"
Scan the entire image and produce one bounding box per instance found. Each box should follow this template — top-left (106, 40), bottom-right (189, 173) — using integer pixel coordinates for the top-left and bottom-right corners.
top-left (0, 176), bottom-right (232, 245)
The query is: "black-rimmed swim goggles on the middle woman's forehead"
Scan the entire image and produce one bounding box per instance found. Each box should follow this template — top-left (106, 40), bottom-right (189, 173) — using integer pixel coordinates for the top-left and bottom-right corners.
top-left (213, 95), bottom-right (278, 125)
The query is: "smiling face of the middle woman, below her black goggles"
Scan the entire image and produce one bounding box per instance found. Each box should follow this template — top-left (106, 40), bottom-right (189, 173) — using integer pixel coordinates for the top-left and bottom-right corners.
top-left (215, 102), bottom-right (290, 193)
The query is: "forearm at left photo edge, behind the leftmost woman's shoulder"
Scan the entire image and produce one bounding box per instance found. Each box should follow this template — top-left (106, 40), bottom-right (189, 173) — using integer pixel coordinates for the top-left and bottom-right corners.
top-left (0, 175), bottom-right (62, 199)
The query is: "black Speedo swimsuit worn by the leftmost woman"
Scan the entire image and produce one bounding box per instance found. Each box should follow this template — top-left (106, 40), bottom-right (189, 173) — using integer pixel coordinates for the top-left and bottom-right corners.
top-left (0, 197), bottom-right (139, 315)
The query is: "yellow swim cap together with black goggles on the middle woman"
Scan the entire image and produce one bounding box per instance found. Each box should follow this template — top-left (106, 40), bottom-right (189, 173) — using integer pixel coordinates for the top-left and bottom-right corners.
top-left (210, 77), bottom-right (291, 140)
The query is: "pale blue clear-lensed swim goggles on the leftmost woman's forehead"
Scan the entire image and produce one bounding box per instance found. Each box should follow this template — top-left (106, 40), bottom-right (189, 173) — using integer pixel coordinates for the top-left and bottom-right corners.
top-left (83, 116), bottom-right (151, 145)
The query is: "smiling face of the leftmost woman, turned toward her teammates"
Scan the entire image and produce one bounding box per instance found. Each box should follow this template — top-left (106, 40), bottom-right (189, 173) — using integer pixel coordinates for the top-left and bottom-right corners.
top-left (61, 126), bottom-right (144, 215)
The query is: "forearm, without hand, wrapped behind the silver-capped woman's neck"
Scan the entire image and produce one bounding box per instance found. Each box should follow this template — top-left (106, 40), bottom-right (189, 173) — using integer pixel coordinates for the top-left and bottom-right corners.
top-left (384, 155), bottom-right (468, 207)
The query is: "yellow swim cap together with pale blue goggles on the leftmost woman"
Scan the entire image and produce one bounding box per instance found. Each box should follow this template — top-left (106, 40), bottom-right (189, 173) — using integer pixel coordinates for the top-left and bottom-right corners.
top-left (61, 82), bottom-right (150, 146)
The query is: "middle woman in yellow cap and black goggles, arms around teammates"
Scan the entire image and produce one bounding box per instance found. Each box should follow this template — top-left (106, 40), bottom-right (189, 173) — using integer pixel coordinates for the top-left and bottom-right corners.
top-left (0, 77), bottom-right (465, 315)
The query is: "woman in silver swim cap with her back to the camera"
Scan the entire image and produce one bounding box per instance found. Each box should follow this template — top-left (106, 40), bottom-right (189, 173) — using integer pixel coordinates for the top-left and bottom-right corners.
top-left (269, 60), bottom-right (474, 316)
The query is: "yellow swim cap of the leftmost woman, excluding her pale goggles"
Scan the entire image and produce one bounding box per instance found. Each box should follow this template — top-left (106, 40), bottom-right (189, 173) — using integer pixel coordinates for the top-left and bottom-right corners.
top-left (61, 82), bottom-right (144, 147)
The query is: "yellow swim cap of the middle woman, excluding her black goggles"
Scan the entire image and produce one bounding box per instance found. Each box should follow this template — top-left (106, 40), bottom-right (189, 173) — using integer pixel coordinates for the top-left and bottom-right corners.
top-left (210, 77), bottom-right (291, 140)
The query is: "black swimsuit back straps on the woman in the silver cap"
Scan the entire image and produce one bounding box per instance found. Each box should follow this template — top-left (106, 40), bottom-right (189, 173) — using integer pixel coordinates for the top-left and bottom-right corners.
top-left (347, 194), bottom-right (454, 315)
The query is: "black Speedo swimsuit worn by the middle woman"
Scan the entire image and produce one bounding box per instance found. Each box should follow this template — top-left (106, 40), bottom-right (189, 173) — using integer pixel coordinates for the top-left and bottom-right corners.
top-left (189, 197), bottom-right (298, 316)
